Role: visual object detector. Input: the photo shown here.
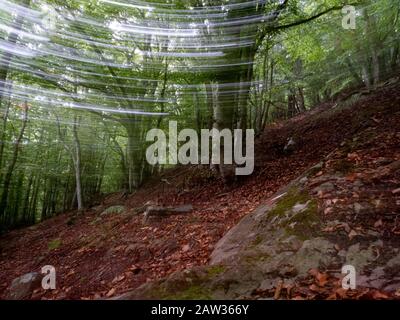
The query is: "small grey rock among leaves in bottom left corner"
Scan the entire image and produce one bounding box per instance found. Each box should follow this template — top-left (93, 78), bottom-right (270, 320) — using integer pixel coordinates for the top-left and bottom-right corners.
top-left (8, 272), bottom-right (43, 300)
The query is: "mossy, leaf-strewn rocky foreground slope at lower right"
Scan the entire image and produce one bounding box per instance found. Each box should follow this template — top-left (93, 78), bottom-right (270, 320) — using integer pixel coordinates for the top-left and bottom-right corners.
top-left (115, 80), bottom-right (400, 299)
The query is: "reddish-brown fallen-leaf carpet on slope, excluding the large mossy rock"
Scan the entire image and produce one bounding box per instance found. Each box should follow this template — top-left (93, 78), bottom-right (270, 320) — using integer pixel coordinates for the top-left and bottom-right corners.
top-left (0, 79), bottom-right (400, 299)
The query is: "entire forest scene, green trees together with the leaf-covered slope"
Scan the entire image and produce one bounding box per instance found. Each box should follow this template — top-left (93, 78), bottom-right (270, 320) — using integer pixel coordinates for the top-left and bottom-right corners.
top-left (0, 0), bottom-right (400, 300)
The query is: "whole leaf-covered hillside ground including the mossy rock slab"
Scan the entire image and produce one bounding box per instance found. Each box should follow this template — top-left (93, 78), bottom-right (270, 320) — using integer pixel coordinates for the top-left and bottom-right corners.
top-left (0, 79), bottom-right (400, 299)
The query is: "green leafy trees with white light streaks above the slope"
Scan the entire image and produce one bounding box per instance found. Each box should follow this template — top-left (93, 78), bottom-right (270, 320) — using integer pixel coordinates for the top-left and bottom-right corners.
top-left (0, 0), bottom-right (400, 231)
